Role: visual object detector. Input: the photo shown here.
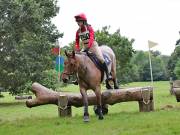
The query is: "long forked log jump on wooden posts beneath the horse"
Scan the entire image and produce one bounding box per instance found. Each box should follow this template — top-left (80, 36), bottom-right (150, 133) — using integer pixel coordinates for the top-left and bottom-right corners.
top-left (26, 83), bottom-right (154, 115)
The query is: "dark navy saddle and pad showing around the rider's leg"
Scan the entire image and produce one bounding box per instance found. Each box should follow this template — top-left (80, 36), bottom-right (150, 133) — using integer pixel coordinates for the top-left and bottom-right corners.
top-left (87, 52), bottom-right (111, 82)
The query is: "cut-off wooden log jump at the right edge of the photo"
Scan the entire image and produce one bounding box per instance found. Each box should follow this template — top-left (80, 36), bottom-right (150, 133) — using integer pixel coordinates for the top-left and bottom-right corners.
top-left (171, 80), bottom-right (180, 102)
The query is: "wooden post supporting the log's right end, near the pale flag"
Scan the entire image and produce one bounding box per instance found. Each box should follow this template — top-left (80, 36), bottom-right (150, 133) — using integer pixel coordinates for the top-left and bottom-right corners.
top-left (138, 88), bottom-right (154, 112)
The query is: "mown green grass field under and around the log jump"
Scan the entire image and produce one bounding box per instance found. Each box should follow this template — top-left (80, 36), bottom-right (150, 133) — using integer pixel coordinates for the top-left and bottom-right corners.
top-left (0, 81), bottom-right (180, 135)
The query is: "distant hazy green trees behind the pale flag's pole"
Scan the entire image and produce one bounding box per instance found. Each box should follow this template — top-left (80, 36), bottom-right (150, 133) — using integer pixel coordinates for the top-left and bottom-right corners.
top-left (131, 51), bottom-right (169, 81)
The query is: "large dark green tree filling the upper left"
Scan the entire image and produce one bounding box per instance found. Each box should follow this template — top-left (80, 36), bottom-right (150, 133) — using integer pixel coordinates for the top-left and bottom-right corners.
top-left (0, 0), bottom-right (62, 94)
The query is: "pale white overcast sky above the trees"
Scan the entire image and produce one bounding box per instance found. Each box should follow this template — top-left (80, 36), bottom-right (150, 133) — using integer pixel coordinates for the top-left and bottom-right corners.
top-left (52, 0), bottom-right (180, 55)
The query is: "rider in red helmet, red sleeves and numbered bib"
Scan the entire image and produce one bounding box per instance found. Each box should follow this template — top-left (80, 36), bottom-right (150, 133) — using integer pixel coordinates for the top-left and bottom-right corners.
top-left (75, 13), bottom-right (112, 84)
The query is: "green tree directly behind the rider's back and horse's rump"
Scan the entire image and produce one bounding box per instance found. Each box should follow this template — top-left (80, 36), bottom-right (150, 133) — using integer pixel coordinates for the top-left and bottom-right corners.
top-left (95, 26), bottom-right (134, 82)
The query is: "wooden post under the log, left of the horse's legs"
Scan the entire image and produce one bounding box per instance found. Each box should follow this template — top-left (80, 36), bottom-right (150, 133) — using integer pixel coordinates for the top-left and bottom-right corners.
top-left (58, 95), bottom-right (72, 117)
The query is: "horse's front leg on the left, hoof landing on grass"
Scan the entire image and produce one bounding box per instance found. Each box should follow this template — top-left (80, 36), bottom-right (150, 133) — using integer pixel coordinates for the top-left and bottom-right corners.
top-left (80, 88), bottom-right (89, 122)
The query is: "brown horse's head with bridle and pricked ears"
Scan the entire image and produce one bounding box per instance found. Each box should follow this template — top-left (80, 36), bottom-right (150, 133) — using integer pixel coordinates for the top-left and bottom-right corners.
top-left (62, 50), bottom-right (77, 83)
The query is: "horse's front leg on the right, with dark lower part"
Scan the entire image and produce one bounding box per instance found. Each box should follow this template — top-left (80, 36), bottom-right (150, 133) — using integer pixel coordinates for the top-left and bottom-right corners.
top-left (95, 86), bottom-right (104, 120)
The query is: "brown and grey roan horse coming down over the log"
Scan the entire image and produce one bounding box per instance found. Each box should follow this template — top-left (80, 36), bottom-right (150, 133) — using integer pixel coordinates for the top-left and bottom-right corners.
top-left (62, 45), bottom-right (118, 122)
